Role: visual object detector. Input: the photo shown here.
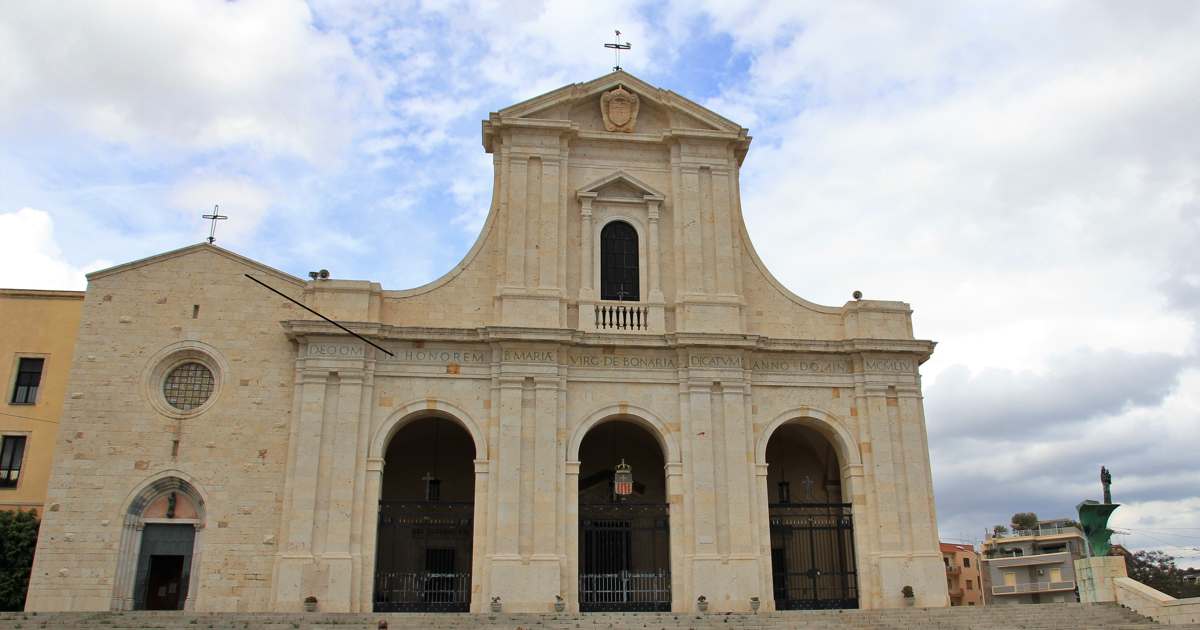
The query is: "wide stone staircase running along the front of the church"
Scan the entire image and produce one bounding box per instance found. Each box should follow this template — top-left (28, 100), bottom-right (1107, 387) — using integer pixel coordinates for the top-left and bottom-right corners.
top-left (0, 604), bottom-right (1200, 630)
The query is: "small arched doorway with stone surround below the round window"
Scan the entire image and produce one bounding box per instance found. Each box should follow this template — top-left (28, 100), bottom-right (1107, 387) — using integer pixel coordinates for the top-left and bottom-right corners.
top-left (112, 476), bottom-right (205, 611)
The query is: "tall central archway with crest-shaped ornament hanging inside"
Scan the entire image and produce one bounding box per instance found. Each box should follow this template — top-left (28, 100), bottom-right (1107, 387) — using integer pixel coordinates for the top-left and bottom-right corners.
top-left (578, 420), bottom-right (671, 612)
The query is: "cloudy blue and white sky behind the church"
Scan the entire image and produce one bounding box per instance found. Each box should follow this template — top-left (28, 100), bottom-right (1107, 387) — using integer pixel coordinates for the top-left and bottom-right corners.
top-left (0, 0), bottom-right (1200, 565)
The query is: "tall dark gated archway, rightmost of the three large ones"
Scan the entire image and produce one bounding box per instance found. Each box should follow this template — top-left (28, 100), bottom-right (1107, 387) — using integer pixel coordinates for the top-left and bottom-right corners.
top-left (767, 424), bottom-right (858, 610)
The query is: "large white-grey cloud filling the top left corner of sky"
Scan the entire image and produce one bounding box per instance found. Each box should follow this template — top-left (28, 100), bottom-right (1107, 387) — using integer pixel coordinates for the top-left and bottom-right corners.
top-left (0, 0), bottom-right (383, 161)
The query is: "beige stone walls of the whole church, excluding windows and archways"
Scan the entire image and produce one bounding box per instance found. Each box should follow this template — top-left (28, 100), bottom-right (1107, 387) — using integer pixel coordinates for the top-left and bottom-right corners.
top-left (30, 72), bottom-right (947, 611)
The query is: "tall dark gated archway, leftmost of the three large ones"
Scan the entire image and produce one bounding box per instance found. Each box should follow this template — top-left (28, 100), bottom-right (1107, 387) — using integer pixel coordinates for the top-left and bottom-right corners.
top-left (374, 418), bottom-right (475, 612)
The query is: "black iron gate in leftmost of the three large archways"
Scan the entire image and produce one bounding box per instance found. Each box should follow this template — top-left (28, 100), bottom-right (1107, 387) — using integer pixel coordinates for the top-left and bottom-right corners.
top-left (374, 500), bottom-right (475, 612)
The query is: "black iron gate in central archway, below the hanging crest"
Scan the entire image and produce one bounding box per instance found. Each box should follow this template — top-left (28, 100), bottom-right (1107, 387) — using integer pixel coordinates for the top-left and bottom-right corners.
top-left (580, 503), bottom-right (671, 612)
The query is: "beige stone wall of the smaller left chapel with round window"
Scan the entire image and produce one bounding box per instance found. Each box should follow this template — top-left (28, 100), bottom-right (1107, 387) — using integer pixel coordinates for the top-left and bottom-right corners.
top-left (26, 246), bottom-right (302, 611)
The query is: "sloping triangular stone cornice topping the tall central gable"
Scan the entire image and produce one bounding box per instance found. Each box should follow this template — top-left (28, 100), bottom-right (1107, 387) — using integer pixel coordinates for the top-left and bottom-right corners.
top-left (498, 70), bottom-right (743, 132)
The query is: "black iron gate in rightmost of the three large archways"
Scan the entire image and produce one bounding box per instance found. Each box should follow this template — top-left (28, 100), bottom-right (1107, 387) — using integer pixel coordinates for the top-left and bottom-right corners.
top-left (769, 503), bottom-right (858, 611)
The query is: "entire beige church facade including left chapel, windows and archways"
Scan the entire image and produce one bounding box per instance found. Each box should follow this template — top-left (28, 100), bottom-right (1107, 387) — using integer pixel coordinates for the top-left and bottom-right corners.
top-left (26, 71), bottom-right (947, 612)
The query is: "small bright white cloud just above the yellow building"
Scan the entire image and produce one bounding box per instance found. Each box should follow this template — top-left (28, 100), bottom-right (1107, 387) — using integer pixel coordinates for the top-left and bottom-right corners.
top-left (0, 208), bottom-right (112, 290)
